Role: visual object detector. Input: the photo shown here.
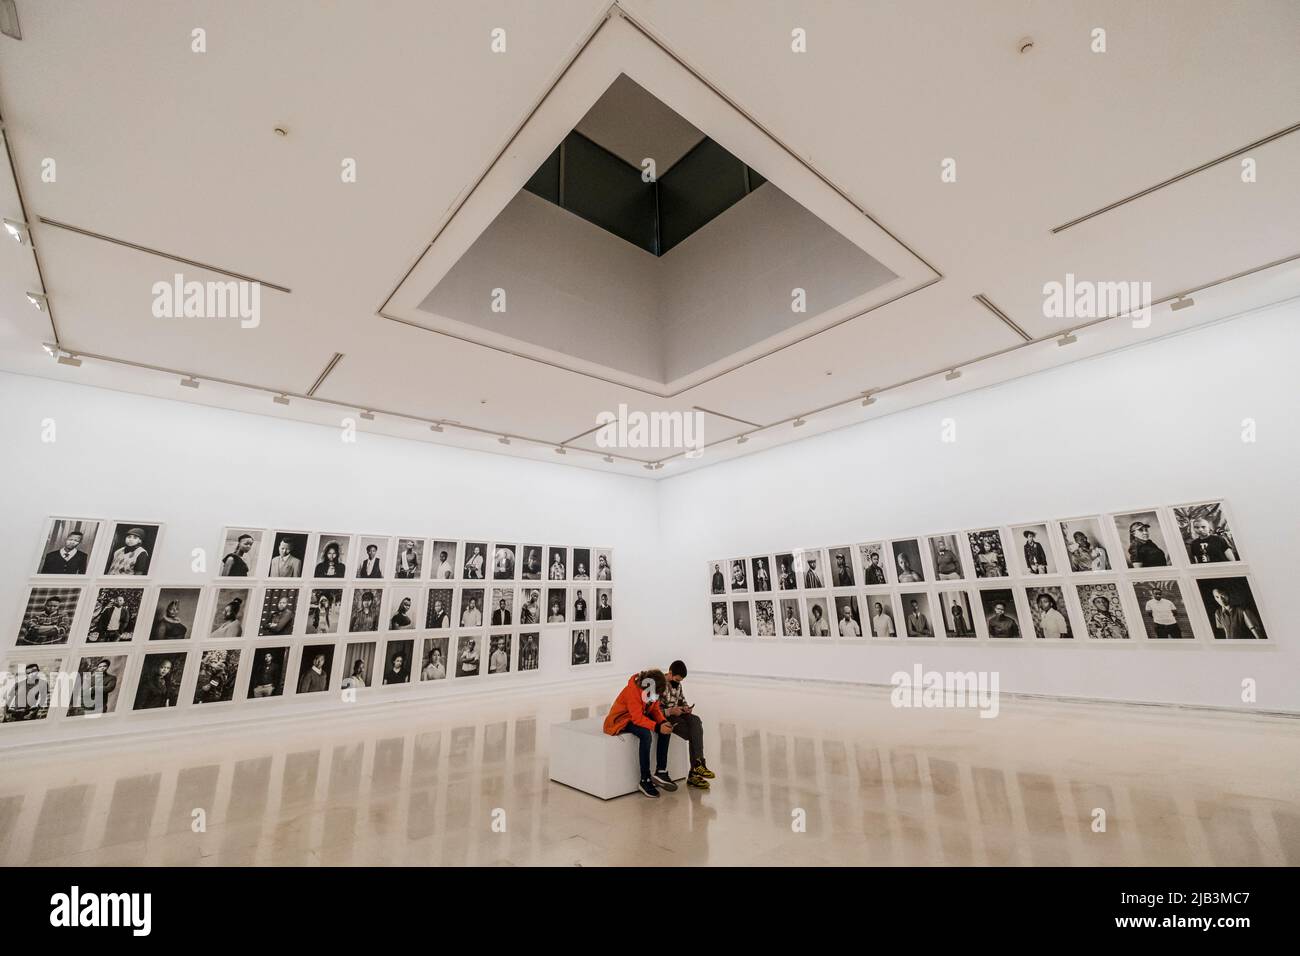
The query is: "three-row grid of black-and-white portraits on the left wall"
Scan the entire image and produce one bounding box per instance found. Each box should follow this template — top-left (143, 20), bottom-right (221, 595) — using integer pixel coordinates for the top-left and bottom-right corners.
top-left (0, 516), bottom-right (618, 724)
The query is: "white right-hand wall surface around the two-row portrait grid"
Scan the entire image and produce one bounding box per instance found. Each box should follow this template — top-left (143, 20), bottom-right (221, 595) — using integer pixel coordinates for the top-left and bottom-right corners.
top-left (655, 302), bottom-right (1300, 711)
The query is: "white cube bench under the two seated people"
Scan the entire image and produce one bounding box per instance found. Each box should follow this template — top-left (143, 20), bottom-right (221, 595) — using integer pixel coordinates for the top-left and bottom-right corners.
top-left (550, 717), bottom-right (690, 800)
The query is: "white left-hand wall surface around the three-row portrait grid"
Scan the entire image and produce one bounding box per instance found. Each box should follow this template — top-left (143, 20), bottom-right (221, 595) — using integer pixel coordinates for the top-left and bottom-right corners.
top-left (0, 373), bottom-right (659, 747)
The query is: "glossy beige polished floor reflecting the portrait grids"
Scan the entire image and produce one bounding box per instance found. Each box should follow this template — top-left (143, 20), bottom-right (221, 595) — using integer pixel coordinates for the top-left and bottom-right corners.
top-left (0, 679), bottom-right (1300, 866)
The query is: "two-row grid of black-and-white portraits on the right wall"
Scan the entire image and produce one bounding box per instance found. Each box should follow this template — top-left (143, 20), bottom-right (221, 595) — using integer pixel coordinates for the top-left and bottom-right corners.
top-left (706, 499), bottom-right (1273, 646)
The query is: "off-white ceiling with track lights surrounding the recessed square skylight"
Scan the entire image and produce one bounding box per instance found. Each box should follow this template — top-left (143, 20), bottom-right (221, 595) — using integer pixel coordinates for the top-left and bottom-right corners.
top-left (0, 0), bottom-right (1300, 476)
